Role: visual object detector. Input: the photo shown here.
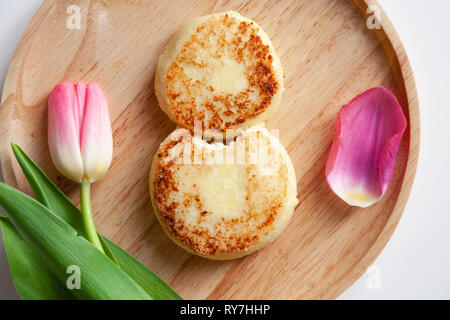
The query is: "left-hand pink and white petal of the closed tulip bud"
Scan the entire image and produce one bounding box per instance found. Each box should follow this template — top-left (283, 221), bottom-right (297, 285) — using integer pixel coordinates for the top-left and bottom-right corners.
top-left (48, 82), bottom-right (83, 182)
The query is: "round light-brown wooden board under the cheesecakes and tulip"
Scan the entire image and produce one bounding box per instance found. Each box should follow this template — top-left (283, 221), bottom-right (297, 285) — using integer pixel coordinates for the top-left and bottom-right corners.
top-left (0, 0), bottom-right (419, 299)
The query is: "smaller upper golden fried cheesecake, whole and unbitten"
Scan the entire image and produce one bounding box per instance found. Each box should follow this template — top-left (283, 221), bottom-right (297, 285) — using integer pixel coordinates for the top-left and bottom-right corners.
top-left (155, 11), bottom-right (284, 136)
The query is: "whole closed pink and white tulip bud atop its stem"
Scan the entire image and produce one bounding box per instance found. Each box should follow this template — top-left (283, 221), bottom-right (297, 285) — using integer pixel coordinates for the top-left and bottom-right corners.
top-left (48, 82), bottom-right (112, 182)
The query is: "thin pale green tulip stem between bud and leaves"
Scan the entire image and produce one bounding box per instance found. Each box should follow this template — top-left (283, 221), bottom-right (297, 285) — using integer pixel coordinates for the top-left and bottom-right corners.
top-left (80, 181), bottom-right (104, 253)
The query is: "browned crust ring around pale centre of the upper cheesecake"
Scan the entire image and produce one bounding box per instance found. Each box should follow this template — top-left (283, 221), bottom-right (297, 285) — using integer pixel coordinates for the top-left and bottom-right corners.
top-left (156, 13), bottom-right (283, 132)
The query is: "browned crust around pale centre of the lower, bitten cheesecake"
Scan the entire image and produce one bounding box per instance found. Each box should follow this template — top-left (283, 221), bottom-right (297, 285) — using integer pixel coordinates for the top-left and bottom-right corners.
top-left (150, 129), bottom-right (296, 258)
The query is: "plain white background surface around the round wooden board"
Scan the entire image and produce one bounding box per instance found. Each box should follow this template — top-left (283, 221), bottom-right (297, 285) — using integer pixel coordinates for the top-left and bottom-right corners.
top-left (0, 0), bottom-right (450, 299)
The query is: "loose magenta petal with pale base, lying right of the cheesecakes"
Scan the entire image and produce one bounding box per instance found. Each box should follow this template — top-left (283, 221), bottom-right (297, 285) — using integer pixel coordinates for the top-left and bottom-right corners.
top-left (326, 87), bottom-right (407, 207)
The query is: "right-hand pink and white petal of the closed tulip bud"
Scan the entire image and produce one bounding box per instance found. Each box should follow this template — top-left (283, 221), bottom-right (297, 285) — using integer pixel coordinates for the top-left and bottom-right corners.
top-left (81, 83), bottom-right (113, 182)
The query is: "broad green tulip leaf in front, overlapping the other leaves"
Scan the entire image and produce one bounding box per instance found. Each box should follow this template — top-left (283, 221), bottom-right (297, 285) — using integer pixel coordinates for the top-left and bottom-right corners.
top-left (0, 183), bottom-right (152, 300)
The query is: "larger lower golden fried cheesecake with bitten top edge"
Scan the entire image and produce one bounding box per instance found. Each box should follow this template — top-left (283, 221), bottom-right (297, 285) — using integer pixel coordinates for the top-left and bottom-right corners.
top-left (150, 126), bottom-right (298, 260)
